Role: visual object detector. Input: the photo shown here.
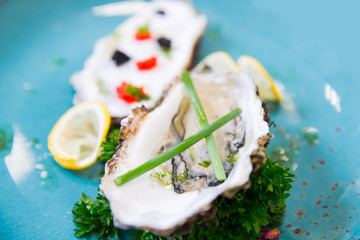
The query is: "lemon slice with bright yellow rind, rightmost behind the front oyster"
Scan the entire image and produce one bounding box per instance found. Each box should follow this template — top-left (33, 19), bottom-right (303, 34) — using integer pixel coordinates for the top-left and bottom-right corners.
top-left (237, 55), bottom-right (282, 101)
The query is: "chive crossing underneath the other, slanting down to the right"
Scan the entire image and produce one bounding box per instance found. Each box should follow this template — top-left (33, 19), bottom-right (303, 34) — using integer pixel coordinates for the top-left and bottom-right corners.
top-left (182, 71), bottom-right (226, 182)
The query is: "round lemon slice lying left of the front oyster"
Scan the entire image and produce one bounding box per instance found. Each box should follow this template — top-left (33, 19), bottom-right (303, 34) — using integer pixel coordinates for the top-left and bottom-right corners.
top-left (48, 101), bottom-right (111, 170)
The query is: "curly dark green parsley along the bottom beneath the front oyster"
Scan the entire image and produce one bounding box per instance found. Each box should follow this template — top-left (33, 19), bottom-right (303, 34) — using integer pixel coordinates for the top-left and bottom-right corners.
top-left (73, 159), bottom-right (294, 240)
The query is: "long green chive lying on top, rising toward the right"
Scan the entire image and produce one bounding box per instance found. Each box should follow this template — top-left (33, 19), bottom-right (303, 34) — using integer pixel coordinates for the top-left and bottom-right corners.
top-left (114, 108), bottom-right (241, 186)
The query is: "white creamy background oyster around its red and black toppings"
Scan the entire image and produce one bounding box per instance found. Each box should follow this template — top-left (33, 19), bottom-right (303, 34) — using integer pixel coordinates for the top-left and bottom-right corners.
top-left (71, 0), bottom-right (207, 117)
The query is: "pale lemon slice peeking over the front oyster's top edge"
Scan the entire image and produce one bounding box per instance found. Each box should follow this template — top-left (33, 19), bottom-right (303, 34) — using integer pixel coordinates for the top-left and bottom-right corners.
top-left (193, 52), bottom-right (240, 74)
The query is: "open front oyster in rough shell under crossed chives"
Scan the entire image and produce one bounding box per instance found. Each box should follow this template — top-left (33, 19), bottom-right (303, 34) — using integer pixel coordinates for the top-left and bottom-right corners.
top-left (100, 52), bottom-right (270, 236)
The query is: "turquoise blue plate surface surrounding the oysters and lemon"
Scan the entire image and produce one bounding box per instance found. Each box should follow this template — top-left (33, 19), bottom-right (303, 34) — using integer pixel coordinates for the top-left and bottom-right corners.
top-left (0, 0), bottom-right (360, 239)
